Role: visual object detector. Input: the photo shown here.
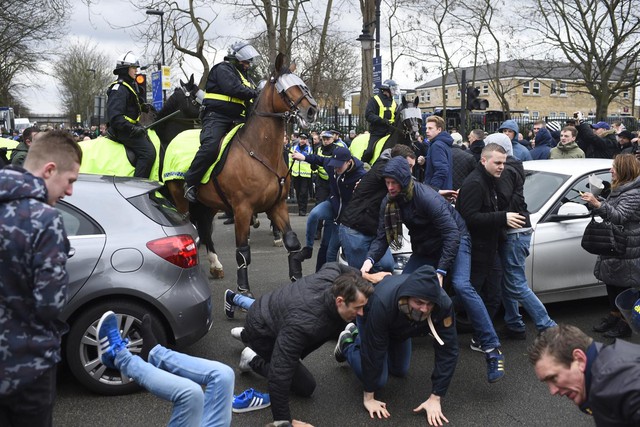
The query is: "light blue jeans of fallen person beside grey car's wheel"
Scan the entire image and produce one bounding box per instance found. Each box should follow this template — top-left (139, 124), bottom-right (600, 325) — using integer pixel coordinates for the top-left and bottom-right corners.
top-left (115, 345), bottom-right (235, 427)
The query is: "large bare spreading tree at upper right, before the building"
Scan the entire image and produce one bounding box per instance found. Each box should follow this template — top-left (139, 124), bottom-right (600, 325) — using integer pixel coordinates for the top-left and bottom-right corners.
top-left (532, 0), bottom-right (640, 119)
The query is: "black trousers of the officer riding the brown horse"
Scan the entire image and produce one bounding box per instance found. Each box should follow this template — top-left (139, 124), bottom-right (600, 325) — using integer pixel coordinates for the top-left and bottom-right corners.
top-left (185, 111), bottom-right (236, 187)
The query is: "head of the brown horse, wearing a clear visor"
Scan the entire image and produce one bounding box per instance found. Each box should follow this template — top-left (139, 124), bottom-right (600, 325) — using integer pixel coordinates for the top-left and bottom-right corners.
top-left (269, 53), bottom-right (318, 128)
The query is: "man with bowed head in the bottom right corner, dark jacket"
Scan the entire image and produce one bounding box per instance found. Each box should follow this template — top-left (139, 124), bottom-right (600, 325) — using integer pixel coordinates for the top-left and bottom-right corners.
top-left (529, 325), bottom-right (640, 427)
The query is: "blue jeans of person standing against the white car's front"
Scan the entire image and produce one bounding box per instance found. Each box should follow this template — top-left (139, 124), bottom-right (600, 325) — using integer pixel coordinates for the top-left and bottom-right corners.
top-left (499, 232), bottom-right (556, 332)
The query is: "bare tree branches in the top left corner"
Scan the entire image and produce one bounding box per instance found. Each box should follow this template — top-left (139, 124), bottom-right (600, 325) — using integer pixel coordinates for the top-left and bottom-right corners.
top-left (0, 0), bottom-right (70, 110)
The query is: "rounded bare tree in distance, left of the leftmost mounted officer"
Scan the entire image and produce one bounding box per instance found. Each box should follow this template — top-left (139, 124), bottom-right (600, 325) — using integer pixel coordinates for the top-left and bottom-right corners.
top-left (53, 42), bottom-right (115, 123)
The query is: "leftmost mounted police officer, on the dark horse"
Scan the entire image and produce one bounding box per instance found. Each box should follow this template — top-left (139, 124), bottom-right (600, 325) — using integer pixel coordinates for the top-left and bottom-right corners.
top-left (107, 52), bottom-right (156, 178)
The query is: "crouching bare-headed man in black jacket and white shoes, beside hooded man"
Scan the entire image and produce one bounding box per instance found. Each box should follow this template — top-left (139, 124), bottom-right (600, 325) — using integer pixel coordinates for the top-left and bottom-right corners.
top-left (234, 263), bottom-right (383, 422)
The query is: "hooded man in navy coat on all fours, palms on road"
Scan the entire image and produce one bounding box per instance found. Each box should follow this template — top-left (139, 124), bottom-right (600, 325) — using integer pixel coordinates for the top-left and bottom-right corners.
top-left (335, 265), bottom-right (458, 425)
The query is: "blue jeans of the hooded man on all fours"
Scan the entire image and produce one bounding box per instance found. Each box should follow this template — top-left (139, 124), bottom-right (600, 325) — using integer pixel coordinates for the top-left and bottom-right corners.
top-left (343, 317), bottom-right (411, 390)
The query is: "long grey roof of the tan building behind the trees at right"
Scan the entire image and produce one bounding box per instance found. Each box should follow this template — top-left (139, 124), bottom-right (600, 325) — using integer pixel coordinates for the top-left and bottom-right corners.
top-left (416, 59), bottom-right (621, 89)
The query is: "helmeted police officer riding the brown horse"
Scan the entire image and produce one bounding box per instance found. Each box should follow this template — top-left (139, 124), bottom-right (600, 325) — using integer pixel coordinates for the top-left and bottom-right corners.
top-left (184, 42), bottom-right (260, 202)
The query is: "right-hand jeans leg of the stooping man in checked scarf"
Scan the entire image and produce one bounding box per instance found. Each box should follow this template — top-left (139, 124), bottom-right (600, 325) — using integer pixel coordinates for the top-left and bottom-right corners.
top-left (451, 234), bottom-right (500, 350)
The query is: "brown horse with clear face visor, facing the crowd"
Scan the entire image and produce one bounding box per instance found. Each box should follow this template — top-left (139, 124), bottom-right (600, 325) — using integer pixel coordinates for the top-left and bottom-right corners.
top-left (167, 54), bottom-right (317, 293)
